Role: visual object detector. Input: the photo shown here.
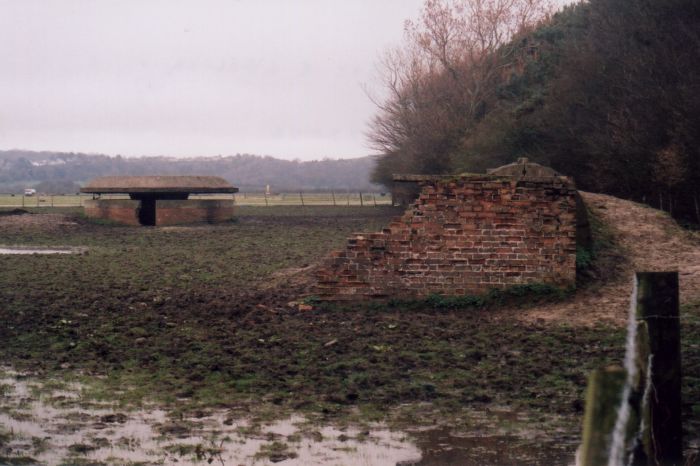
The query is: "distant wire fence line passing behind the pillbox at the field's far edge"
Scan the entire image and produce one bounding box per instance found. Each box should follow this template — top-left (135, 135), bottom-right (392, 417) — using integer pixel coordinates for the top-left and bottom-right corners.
top-left (0, 191), bottom-right (392, 208)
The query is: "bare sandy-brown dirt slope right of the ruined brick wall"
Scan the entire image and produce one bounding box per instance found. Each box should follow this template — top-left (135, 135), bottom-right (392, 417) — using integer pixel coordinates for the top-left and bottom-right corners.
top-left (518, 192), bottom-right (700, 325)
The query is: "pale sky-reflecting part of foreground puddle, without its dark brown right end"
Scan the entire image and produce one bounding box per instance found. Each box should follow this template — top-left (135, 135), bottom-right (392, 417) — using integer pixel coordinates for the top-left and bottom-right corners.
top-left (0, 370), bottom-right (421, 466)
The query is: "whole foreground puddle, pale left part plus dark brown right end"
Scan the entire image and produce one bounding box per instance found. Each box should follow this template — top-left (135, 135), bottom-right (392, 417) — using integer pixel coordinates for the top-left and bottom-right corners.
top-left (0, 367), bottom-right (577, 466)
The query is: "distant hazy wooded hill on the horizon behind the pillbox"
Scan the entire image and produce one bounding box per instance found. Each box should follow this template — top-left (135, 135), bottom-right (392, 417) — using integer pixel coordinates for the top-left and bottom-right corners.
top-left (0, 150), bottom-right (381, 194)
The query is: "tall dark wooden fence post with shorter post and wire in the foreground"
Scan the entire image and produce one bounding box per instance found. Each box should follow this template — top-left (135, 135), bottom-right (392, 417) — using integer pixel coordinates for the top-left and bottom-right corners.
top-left (580, 272), bottom-right (683, 466)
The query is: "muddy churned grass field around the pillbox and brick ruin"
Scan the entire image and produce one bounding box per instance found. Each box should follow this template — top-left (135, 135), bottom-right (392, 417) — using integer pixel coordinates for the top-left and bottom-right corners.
top-left (0, 207), bottom-right (700, 465)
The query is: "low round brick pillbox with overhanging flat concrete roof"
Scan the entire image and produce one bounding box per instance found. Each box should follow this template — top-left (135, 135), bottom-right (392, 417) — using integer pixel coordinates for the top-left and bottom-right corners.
top-left (80, 176), bottom-right (238, 226)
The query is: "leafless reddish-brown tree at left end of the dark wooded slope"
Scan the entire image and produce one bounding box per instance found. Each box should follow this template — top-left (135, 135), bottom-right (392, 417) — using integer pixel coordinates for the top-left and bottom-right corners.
top-left (368, 0), bottom-right (551, 183)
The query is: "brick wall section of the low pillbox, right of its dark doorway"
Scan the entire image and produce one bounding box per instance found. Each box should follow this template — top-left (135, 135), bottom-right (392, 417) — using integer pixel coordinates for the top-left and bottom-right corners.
top-left (156, 199), bottom-right (234, 225)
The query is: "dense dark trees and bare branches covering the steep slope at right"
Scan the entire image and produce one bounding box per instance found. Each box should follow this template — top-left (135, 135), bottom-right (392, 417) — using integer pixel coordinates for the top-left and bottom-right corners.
top-left (370, 0), bottom-right (700, 222)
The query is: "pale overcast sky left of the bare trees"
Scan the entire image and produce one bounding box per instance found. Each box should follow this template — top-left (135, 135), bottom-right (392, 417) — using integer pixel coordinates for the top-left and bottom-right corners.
top-left (0, 0), bottom-right (572, 160)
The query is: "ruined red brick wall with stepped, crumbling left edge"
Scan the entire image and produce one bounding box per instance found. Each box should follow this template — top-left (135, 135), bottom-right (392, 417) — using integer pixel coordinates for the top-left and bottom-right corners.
top-left (312, 176), bottom-right (576, 299)
